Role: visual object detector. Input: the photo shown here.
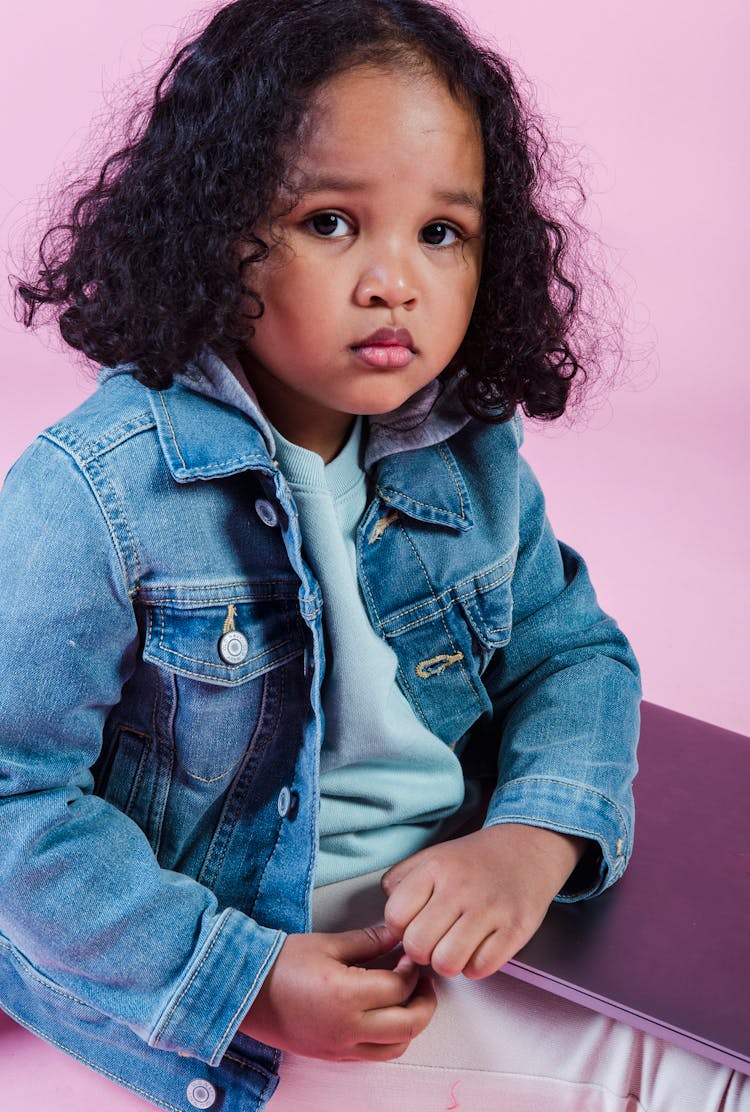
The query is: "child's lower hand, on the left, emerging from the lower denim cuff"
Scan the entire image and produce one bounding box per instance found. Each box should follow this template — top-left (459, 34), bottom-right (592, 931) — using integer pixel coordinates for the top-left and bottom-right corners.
top-left (239, 926), bottom-right (436, 1062)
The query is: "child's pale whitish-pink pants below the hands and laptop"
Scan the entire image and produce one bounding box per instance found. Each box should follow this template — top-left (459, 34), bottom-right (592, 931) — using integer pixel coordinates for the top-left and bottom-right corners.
top-left (268, 873), bottom-right (750, 1112)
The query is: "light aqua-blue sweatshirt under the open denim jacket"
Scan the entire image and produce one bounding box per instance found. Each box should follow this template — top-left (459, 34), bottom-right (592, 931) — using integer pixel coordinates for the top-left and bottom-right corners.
top-left (274, 418), bottom-right (473, 885)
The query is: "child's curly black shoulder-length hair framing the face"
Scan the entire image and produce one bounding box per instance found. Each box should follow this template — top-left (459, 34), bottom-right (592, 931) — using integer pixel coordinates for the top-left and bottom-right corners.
top-left (17, 0), bottom-right (605, 420)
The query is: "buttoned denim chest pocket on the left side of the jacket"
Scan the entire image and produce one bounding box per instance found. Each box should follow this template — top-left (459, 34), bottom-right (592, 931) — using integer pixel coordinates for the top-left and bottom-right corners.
top-left (142, 582), bottom-right (305, 782)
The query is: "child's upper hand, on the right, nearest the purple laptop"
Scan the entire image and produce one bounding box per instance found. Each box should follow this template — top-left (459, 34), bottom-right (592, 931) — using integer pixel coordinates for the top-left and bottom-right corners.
top-left (382, 823), bottom-right (586, 980)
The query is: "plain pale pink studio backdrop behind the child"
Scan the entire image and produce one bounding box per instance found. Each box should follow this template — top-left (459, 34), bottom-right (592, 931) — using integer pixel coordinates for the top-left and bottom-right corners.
top-left (0, 0), bottom-right (750, 1112)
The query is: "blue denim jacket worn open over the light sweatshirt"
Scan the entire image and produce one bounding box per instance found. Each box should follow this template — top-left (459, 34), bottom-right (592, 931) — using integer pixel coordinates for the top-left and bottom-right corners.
top-left (0, 364), bottom-right (639, 1112)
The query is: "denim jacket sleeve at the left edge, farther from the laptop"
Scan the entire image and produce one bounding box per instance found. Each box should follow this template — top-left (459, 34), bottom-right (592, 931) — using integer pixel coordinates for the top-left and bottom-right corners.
top-left (0, 439), bottom-right (284, 1064)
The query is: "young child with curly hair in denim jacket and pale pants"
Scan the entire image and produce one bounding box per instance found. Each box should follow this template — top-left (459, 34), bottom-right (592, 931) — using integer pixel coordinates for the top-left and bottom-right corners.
top-left (0, 0), bottom-right (749, 1112)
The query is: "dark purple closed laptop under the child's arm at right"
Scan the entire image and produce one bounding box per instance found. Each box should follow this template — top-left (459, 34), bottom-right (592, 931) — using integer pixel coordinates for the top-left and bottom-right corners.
top-left (504, 703), bottom-right (750, 1074)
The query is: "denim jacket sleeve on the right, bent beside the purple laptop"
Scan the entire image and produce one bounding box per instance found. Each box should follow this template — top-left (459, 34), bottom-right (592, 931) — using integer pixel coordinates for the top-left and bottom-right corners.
top-left (484, 438), bottom-right (640, 901)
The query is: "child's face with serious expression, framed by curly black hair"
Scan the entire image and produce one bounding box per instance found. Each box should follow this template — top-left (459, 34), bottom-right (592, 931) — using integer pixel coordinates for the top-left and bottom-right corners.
top-left (243, 64), bottom-right (484, 460)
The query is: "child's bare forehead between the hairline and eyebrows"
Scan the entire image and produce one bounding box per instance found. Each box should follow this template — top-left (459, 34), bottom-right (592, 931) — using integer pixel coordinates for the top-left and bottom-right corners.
top-left (293, 64), bottom-right (484, 189)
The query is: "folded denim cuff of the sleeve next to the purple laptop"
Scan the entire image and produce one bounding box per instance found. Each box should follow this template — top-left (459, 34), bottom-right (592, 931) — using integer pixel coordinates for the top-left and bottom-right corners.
top-left (484, 776), bottom-right (632, 903)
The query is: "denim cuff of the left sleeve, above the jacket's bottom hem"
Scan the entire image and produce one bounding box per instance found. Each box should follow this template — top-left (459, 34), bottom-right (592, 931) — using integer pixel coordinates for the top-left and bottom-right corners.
top-left (148, 907), bottom-right (286, 1065)
